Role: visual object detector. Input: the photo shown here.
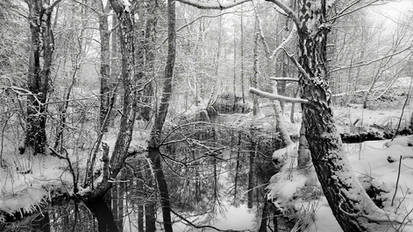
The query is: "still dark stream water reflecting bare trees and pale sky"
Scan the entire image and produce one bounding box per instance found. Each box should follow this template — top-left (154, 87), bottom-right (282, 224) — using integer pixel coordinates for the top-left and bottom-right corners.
top-left (7, 124), bottom-right (280, 232)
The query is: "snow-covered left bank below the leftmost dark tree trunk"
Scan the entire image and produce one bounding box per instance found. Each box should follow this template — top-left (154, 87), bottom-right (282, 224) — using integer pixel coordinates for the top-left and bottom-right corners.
top-left (0, 155), bottom-right (71, 220)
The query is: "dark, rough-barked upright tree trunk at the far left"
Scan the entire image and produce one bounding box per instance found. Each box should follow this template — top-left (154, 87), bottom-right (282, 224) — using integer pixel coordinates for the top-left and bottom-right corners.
top-left (21, 0), bottom-right (54, 154)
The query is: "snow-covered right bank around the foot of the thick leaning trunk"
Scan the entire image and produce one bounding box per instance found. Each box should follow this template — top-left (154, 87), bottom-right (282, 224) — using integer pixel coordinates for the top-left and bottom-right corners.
top-left (269, 136), bottom-right (413, 232)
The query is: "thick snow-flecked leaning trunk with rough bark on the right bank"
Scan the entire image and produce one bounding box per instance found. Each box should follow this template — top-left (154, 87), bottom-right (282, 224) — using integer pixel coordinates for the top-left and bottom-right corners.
top-left (297, 0), bottom-right (400, 232)
